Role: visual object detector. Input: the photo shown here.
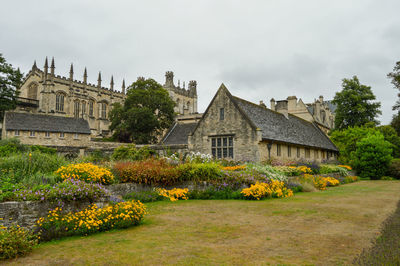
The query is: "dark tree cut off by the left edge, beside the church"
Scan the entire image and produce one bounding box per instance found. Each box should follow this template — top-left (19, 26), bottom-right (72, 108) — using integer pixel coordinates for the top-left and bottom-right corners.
top-left (0, 54), bottom-right (24, 121)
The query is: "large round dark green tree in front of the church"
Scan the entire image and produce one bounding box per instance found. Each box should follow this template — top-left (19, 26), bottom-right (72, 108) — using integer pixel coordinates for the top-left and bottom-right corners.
top-left (110, 78), bottom-right (175, 144)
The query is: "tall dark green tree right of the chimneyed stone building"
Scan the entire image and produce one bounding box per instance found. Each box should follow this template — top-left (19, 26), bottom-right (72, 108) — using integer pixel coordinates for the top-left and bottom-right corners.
top-left (333, 76), bottom-right (381, 129)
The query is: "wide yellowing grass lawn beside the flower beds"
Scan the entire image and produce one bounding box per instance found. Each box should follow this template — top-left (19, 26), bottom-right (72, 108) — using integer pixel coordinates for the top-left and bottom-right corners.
top-left (8, 181), bottom-right (400, 265)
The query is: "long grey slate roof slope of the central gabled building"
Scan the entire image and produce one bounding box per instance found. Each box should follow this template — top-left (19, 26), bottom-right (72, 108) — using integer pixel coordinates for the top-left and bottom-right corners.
top-left (232, 96), bottom-right (338, 151)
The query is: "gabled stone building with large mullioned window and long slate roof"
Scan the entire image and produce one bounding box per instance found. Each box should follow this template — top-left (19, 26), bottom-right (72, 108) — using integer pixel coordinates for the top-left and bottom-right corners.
top-left (188, 84), bottom-right (338, 161)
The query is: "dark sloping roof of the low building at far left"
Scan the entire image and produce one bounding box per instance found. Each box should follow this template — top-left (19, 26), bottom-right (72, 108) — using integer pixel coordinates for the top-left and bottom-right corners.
top-left (4, 112), bottom-right (90, 134)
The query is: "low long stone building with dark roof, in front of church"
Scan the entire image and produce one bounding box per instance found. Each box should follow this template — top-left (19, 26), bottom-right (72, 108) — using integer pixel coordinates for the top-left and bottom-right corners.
top-left (2, 112), bottom-right (91, 147)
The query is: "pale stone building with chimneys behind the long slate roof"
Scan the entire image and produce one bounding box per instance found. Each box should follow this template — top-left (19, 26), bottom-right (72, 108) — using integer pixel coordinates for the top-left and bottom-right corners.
top-left (271, 96), bottom-right (336, 134)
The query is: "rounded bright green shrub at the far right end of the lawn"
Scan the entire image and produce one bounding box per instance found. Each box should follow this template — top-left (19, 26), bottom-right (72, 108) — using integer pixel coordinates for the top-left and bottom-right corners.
top-left (354, 134), bottom-right (392, 179)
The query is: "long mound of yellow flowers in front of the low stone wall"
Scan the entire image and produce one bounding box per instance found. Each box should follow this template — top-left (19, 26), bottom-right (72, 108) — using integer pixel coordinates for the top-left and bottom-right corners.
top-left (36, 201), bottom-right (146, 241)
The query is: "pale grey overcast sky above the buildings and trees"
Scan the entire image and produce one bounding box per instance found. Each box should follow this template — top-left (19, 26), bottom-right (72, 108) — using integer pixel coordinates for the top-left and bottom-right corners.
top-left (0, 0), bottom-right (400, 124)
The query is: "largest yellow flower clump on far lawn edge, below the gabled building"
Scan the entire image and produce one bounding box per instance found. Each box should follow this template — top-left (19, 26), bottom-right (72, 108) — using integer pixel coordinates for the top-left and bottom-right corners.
top-left (241, 180), bottom-right (293, 200)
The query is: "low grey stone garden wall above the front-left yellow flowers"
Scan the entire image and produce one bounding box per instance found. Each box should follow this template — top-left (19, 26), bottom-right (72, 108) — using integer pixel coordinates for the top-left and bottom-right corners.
top-left (0, 201), bottom-right (105, 229)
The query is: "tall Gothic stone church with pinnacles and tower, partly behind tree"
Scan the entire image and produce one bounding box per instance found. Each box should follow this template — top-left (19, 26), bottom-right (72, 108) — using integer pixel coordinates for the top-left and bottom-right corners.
top-left (6, 58), bottom-right (197, 144)
